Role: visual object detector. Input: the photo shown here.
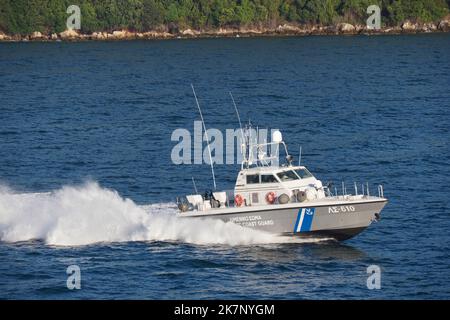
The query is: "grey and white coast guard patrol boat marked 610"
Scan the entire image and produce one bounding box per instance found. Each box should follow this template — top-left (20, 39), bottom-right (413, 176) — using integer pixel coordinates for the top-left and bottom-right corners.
top-left (177, 128), bottom-right (387, 241)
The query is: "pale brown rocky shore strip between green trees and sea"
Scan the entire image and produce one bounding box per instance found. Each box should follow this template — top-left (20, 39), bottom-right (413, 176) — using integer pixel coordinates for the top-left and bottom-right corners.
top-left (0, 17), bottom-right (450, 42)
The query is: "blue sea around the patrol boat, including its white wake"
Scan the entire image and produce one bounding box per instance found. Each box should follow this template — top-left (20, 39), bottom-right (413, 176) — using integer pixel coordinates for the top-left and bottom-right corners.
top-left (0, 34), bottom-right (450, 299)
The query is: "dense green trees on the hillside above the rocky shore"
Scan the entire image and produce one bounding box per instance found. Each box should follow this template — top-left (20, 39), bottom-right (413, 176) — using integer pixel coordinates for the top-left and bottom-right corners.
top-left (0, 0), bottom-right (450, 35)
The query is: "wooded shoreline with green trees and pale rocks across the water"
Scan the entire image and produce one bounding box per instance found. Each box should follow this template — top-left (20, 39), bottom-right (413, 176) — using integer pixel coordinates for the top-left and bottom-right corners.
top-left (0, 0), bottom-right (450, 42)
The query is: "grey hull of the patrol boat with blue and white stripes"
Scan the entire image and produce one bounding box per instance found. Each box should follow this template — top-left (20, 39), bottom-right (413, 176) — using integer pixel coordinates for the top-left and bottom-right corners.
top-left (179, 197), bottom-right (387, 241)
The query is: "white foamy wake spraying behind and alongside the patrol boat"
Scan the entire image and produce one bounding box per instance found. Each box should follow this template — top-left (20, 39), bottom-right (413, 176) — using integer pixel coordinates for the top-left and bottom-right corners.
top-left (0, 182), bottom-right (328, 246)
